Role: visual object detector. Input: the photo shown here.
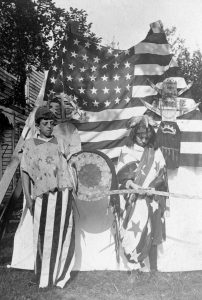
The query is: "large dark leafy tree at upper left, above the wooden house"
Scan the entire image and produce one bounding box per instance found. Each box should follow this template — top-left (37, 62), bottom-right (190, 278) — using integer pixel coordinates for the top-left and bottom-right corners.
top-left (0, 0), bottom-right (99, 106)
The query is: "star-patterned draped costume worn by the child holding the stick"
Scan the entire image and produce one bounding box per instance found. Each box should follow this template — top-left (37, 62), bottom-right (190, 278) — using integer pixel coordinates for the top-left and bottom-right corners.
top-left (117, 144), bottom-right (167, 265)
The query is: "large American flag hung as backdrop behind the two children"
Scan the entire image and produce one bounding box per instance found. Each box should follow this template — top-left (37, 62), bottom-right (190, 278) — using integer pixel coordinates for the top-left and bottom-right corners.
top-left (45, 22), bottom-right (202, 165)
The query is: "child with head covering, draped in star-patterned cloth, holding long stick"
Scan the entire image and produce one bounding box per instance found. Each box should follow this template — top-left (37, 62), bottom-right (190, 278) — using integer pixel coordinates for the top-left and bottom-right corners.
top-left (117, 116), bottom-right (168, 272)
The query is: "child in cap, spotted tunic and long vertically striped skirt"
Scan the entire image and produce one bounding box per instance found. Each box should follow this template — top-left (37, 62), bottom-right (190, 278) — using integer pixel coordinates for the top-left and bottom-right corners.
top-left (21, 107), bottom-right (76, 288)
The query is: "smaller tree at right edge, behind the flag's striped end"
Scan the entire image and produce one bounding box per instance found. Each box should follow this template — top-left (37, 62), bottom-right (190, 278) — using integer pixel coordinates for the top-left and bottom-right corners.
top-left (165, 27), bottom-right (202, 102)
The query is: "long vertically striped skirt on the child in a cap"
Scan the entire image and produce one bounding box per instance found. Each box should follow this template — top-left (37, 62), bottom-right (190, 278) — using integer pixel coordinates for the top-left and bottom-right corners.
top-left (34, 189), bottom-right (75, 288)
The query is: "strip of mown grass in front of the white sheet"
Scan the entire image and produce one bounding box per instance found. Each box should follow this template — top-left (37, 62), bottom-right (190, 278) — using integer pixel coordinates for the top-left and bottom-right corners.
top-left (0, 230), bottom-right (202, 300)
